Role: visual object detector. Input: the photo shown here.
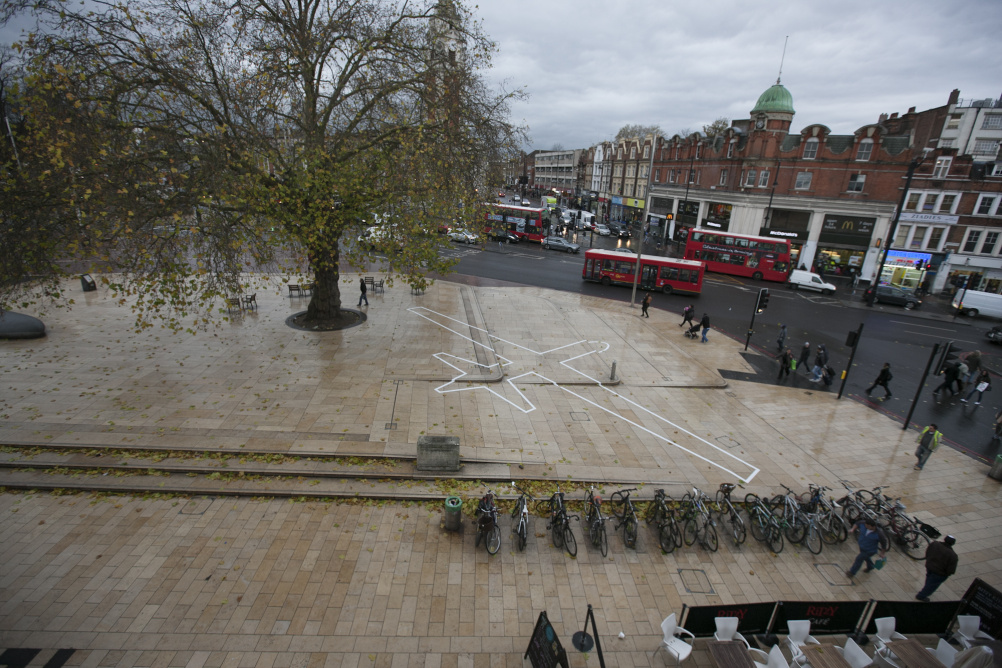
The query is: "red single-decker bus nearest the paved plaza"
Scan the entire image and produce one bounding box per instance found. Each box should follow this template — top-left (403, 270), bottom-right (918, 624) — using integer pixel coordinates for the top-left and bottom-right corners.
top-left (581, 248), bottom-right (703, 294)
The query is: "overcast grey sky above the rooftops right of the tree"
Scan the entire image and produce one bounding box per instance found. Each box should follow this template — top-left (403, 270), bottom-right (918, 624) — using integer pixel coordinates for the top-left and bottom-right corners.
top-left (473, 0), bottom-right (1002, 150)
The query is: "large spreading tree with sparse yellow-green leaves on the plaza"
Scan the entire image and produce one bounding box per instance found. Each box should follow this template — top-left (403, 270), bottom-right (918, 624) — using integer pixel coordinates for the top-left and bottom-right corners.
top-left (0, 0), bottom-right (521, 329)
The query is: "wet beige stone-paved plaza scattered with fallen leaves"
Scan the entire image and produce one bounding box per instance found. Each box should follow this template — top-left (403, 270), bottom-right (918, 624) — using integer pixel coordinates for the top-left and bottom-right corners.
top-left (0, 274), bottom-right (1002, 668)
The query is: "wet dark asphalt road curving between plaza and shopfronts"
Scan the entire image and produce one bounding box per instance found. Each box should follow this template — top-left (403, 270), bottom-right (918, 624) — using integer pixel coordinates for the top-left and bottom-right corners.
top-left (436, 234), bottom-right (1002, 462)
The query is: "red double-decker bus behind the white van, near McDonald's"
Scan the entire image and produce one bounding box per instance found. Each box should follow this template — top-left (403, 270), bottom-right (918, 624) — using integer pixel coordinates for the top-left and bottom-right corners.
top-left (684, 229), bottom-right (791, 282)
